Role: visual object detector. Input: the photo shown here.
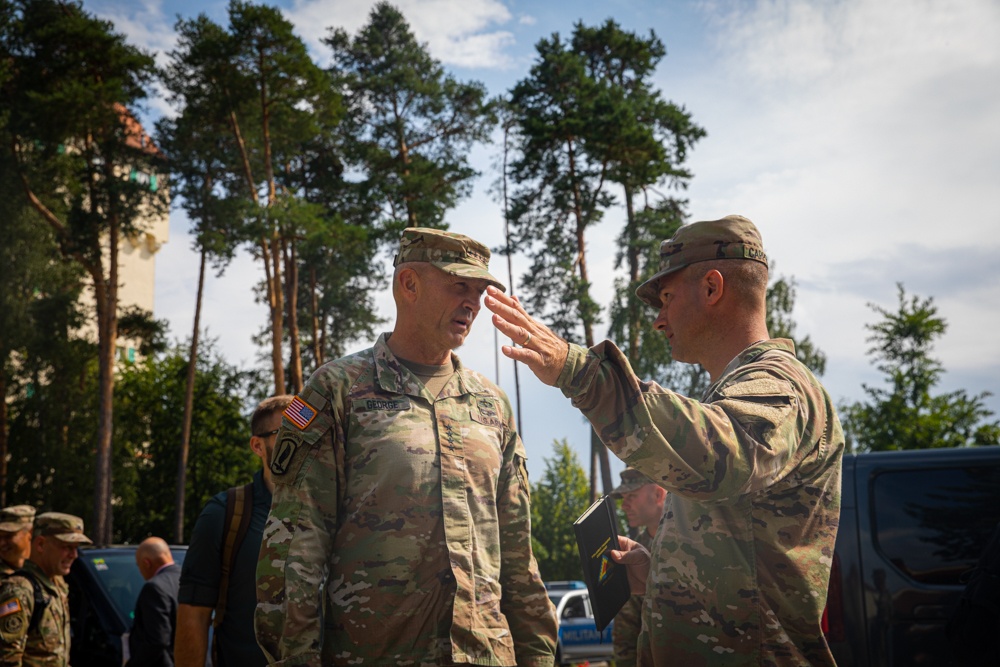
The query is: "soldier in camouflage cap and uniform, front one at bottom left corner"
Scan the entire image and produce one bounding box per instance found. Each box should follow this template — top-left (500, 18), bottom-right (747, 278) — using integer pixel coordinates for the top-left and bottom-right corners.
top-left (0, 512), bottom-right (90, 667)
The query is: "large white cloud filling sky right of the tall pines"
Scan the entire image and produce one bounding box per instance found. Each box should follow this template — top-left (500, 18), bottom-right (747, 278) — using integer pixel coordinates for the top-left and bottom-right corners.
top-left (663, 0), bottom-right (1000, 414)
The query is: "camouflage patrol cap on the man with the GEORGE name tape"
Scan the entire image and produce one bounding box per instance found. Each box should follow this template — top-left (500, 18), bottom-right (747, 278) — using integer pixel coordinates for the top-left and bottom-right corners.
top-left (392, 227), bottom-right (507, 292)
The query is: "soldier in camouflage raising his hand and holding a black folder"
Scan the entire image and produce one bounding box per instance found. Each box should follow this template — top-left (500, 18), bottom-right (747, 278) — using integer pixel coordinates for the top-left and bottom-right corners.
top-left (486, 216), bottom-right (844, 665)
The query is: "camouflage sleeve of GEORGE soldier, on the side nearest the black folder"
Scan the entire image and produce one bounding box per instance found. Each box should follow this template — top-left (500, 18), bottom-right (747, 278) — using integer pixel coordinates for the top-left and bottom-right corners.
top-left (497, 429), bottom-right (558, 667)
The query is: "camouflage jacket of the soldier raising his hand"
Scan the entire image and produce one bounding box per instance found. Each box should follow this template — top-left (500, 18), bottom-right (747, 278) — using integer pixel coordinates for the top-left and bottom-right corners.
top-left (557, 339), bottom-right (844, 666)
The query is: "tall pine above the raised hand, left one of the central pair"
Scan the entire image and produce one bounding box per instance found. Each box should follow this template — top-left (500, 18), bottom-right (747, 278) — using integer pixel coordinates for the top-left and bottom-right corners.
top-left (508, 29), bottom-right (613, 345)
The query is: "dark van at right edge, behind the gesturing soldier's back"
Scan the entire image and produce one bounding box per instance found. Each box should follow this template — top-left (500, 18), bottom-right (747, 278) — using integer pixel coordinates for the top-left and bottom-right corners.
top-left (824, 447), bottom-right (1000, 667)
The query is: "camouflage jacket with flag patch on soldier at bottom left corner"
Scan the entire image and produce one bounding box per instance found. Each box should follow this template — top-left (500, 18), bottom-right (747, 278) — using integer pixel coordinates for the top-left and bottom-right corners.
top-left (0, 560), bottom-right (69, 667)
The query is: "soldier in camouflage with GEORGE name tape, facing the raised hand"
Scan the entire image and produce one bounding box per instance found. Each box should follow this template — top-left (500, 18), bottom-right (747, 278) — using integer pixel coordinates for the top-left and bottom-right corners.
top-left (256, 228), bottom-right (556, 667)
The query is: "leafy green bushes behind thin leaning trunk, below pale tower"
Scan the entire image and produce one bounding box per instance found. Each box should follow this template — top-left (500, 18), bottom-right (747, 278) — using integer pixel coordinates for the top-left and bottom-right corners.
top-left (115, 341), bottom-right (260, 542)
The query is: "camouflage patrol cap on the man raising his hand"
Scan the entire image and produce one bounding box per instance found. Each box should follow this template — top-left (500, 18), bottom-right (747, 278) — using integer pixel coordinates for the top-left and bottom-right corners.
top-left (635, 215), bottom-right (767, 308)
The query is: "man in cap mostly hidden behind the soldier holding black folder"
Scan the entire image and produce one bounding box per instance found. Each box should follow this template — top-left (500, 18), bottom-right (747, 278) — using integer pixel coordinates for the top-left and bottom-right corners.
top-left (611, 468), bottom-right (667, 667)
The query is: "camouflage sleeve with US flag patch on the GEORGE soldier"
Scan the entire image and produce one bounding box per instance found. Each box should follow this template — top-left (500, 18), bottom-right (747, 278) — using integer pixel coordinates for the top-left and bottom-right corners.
top-left (254, 390), bottom-right (340, 667)
